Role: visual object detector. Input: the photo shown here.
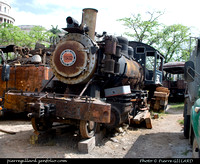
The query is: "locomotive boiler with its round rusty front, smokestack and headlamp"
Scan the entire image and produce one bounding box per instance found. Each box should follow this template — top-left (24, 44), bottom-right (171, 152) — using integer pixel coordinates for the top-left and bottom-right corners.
top-left (51, 9), bottom-right (143, 88)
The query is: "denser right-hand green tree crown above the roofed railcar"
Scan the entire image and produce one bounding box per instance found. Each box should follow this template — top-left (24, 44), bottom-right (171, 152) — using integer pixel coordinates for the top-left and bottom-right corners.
top-left (157, 24), bottom-right (191, 63)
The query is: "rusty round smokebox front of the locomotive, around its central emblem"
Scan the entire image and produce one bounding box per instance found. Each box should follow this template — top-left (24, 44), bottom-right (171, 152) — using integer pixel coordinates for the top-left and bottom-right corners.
top-left (51, 33), bottom-right (97, 84)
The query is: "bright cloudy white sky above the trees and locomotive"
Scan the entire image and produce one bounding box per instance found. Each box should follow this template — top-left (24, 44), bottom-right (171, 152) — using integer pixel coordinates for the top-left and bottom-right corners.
top-left (3, 0), bottom-right (200, 35)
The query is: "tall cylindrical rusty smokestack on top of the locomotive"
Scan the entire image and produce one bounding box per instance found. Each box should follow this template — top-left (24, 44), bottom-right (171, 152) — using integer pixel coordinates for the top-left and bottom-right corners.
top-left (81, 8), bottom-right (98, 40)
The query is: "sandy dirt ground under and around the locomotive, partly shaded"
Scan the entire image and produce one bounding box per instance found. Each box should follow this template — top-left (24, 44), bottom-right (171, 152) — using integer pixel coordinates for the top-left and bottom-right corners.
top-left (0, 103), bottom-right (192, 158)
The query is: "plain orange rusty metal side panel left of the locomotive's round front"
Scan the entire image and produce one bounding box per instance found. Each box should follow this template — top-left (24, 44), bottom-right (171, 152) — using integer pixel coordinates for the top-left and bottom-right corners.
top-left (0, 65), bottom-right (52, 97)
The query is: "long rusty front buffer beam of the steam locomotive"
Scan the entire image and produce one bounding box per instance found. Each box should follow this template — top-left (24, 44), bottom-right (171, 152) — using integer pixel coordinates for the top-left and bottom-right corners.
top-left (4, 92), bottom-right (111, 123)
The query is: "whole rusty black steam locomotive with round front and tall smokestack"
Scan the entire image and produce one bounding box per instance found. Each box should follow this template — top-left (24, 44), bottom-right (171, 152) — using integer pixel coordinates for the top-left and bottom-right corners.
top-left (1, 9), bottom-right (163, 138)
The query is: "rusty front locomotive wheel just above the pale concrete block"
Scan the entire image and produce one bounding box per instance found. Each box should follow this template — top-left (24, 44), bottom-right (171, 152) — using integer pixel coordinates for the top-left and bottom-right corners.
top-left (80, 120), bottom-right (97, 138)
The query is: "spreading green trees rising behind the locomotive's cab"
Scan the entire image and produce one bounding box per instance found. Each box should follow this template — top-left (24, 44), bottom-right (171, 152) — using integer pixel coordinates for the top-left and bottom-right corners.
top-left (119, 11), bottom-right (191, 62)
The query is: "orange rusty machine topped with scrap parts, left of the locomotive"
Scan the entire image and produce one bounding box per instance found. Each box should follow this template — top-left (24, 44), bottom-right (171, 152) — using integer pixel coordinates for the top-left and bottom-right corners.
top-left (0, 43), bottom-right (53, 116)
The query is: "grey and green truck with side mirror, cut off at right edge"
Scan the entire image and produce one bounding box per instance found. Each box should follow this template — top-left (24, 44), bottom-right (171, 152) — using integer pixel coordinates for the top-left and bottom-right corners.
top-left (184, 38), bottom-right (200, 158)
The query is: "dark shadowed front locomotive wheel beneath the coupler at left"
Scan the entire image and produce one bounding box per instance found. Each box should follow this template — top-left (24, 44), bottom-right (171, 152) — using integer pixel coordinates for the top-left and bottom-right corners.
top-left (31, 118), bottom-right (53, 131)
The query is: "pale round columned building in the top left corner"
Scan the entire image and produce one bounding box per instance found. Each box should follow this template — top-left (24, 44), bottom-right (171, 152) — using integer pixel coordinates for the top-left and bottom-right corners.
top-left (0, 0), bottom-right (15, 24)
